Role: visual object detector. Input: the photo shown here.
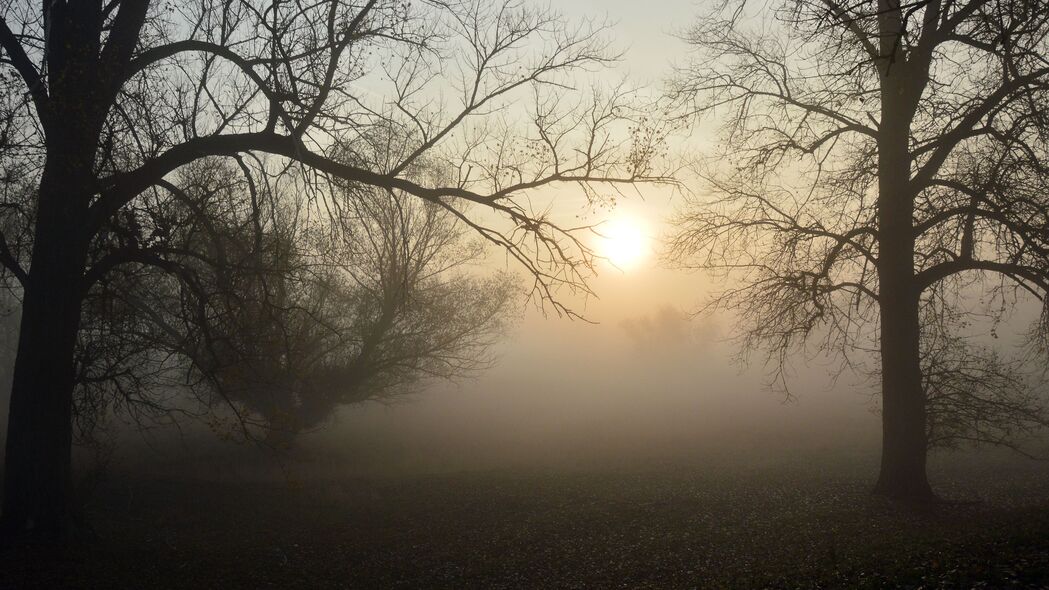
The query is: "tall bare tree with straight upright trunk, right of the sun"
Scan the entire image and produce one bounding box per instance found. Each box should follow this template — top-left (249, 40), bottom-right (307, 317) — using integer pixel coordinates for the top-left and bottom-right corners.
top-left (672, 0), bottom-right (1049, 500)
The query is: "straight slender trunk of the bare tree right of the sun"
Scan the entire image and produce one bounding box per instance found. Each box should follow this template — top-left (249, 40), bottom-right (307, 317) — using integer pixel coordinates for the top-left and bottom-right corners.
top-left (875, 32), bottom-right (934, 502)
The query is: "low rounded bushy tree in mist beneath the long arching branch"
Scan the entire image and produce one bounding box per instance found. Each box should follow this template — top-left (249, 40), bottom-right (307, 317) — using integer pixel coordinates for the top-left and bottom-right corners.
top-left (186, 158), bottom-right (514, 445)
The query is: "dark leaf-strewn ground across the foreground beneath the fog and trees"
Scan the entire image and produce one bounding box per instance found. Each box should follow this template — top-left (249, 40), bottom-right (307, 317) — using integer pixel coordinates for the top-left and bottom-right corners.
top-left (0, 449), bottom-right (1049, 589)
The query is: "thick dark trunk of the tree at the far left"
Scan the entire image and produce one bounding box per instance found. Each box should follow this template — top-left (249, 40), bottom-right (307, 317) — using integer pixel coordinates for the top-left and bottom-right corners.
top-left (0, 2), bottom-right (114, 539)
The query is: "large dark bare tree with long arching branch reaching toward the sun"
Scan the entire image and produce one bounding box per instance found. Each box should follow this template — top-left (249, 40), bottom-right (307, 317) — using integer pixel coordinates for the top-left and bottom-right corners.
top-left (0, 0), bottom-right (671, 533)
